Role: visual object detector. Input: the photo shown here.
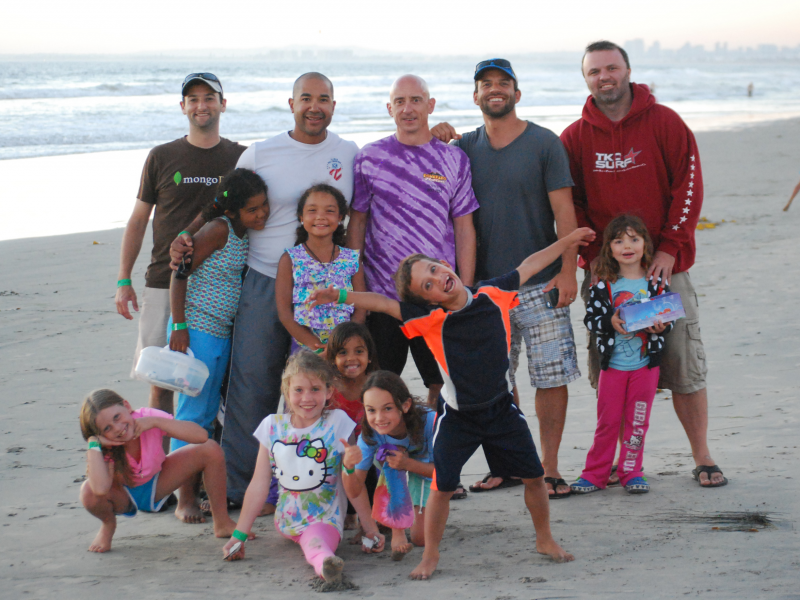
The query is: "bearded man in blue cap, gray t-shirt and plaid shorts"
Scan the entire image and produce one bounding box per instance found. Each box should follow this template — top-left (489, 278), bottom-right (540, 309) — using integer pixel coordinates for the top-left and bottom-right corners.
top-left (432, 59), bottom-right (580, 498)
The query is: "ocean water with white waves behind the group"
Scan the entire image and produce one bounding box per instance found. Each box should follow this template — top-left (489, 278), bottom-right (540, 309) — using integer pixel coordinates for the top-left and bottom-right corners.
top-left (0, 58), bottom-right (800, 160)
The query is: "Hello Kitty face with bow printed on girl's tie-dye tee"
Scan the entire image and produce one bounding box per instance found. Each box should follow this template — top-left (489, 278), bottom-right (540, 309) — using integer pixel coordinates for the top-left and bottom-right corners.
top-left (272, 439), bottom-right (330, 492)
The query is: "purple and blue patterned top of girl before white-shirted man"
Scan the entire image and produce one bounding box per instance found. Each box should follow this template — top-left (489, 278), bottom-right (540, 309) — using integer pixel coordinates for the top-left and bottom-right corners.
top-left (286, 244), bottom-right (358, 342)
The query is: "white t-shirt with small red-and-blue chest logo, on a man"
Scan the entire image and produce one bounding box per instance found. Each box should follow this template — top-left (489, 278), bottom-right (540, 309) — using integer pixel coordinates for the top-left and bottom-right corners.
top-left (236, 131), bottom-right (358, 278)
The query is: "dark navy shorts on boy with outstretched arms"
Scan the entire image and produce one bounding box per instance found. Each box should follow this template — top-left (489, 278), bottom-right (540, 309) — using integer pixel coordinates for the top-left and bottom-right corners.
top-left (431, 394), bottom-right (544, 492)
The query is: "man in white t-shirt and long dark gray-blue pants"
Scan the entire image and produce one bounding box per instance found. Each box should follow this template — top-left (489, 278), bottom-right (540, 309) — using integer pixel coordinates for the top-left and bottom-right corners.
top-left (173, 73), bottom-right (358, 505)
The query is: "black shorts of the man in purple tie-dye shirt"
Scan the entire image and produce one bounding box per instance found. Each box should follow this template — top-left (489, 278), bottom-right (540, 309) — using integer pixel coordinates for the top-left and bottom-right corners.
top-left (367, 313), bottom-right (444, 387)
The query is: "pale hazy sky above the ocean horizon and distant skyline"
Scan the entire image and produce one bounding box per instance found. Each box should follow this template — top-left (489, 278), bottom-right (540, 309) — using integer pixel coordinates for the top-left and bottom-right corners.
top-left (0, 0), bottom-right (800, 55)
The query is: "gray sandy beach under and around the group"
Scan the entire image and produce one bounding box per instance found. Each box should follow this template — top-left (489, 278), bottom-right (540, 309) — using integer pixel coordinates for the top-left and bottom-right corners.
top-left (0, 120), bottom-right (800, 600)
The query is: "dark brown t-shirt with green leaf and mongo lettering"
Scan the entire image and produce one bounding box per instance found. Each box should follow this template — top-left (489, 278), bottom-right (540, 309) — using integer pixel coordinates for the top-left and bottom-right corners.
top-left (136, 137), bottom-right (245, 289)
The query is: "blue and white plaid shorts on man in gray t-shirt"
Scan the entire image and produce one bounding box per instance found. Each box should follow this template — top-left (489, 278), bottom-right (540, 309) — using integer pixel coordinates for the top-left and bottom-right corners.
top-left (510, 283), bottom-right (581, 388)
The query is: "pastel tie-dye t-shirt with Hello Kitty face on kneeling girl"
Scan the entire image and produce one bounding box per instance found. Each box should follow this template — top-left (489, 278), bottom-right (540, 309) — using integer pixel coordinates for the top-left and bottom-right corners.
top-left (253, 409), bottom-right (355, 536)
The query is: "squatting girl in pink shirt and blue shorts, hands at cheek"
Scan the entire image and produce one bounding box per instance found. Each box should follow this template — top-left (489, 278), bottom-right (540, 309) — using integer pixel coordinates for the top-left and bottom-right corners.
top-left (80, 390), bottom-right (236, 552)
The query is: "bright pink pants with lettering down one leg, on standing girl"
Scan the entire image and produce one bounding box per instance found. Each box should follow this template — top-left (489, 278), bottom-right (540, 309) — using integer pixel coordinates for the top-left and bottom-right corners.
top-left (581, 367), bottom-right (659, 489)
